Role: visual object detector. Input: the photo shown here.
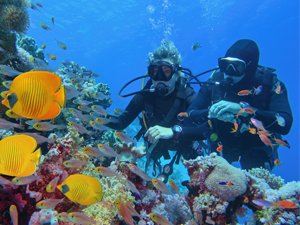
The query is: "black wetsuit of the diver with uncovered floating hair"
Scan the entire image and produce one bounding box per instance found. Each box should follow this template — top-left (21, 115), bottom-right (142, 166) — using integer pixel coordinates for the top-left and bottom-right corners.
top-left (106, 79), bottom-right (197, 160)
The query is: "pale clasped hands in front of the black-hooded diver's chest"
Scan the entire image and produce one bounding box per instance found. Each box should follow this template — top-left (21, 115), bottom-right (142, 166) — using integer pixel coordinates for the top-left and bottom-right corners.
top-left (208, 100), bottom-right (242, 118)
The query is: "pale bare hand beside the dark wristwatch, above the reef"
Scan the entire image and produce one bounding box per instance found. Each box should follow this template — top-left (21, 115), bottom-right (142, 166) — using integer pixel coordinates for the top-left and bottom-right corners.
top-left (144, 125), bottom-right (174, 143)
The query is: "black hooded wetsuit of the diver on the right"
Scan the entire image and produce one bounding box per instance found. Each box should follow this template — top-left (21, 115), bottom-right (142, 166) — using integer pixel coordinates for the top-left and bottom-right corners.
top-left (182, 40), bottom-right (293, 169)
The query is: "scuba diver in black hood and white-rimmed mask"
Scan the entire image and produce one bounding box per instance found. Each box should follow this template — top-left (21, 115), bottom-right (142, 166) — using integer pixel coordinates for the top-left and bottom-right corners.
top-left (145, 39), bottom-right (293, 170)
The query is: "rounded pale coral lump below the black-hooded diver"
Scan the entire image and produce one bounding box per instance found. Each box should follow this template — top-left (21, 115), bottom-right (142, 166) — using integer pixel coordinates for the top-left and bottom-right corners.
top-left (205, 156), bottom-right (247, 201)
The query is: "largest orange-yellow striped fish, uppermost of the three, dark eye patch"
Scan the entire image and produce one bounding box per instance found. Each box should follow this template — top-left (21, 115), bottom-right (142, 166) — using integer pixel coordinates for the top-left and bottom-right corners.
top-left (2, 71), bottom-right (66, 120)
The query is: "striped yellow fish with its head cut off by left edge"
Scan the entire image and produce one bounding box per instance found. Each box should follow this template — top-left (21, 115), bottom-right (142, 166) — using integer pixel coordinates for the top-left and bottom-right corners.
top-left (0, 134), bottom-right (41, 177)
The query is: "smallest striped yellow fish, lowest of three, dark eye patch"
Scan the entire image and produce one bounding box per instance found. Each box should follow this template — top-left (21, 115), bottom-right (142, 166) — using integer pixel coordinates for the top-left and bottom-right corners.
top-left (57, 174), bottom-right (103, 205)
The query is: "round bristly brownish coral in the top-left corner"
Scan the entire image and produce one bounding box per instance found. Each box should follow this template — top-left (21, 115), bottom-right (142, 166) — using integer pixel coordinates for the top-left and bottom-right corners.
top-left (0, 4), bottom-right (29, 33)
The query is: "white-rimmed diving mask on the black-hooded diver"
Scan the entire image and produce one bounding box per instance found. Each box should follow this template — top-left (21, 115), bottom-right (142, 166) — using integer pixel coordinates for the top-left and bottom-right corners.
top-left (218, 57), bottom-right (247, 77)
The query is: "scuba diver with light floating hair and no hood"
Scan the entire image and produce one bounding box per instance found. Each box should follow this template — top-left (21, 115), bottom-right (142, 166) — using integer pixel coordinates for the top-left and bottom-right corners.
top-left (105, 41), bottom-right (197, 182)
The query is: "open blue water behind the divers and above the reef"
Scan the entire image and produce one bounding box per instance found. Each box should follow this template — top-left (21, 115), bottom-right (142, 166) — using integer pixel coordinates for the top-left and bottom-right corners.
top-left (28, 0), bottom-right (300, 181)
